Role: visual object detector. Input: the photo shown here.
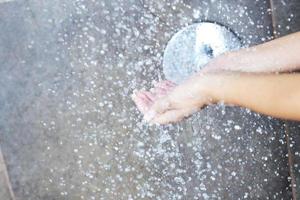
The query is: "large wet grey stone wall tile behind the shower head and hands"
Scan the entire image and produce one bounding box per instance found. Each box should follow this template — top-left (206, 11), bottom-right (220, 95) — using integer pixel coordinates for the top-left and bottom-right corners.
top-left (0, 0), bottom-right (298, 200)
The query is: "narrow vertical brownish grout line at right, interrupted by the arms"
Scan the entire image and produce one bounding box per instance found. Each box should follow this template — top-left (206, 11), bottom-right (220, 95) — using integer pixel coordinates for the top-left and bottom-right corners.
top-left (270, 0), bottom-right (297, 200)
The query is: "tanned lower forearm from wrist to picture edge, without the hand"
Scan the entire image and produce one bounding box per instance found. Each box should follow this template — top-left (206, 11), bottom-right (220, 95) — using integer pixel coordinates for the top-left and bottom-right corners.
top-left (200, 73), bottom-right (300, 120)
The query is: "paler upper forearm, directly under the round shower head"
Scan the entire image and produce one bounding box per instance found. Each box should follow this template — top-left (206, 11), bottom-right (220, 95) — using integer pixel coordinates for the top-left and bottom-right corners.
top-left (207, 32), bottom-right (300, 72)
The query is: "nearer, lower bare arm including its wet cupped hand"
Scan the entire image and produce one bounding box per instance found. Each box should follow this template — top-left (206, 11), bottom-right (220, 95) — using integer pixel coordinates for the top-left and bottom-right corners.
top-left (150, 72), bottom-right (300, 124)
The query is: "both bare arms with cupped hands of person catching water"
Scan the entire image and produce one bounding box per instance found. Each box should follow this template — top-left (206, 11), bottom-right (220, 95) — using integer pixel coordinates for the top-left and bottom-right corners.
top-left (133, 33), bottom-right (300, 124)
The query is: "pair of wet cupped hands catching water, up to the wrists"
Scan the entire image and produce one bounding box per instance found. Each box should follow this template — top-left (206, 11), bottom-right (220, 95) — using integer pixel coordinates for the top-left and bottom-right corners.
top-left (133, 76), bottom-right (211, 124)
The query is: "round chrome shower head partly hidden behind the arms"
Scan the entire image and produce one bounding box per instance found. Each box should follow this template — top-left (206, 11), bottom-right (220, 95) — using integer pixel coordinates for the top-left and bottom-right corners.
top-left (163, 22), bottom-right (241, 83)
